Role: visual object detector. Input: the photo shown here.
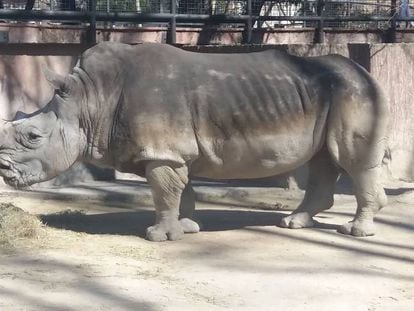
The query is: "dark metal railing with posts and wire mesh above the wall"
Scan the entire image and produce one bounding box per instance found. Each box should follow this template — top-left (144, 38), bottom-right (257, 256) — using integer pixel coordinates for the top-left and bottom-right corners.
top-left (0, 0), bottom-right (414, 44)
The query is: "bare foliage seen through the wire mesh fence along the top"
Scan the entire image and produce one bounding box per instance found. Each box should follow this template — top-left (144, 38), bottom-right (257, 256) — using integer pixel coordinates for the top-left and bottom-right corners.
top-left (0, 0), bottom-right (398, 28)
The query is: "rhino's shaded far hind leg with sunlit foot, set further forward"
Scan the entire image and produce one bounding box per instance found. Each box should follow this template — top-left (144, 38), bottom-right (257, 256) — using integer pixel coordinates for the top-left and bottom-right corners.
top-left (280, 148), bottom-right (339, 229)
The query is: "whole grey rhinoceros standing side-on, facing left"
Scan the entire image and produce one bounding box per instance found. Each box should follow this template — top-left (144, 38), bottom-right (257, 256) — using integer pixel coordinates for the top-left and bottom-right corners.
top-left (0, 43), bottom-right (388, 241)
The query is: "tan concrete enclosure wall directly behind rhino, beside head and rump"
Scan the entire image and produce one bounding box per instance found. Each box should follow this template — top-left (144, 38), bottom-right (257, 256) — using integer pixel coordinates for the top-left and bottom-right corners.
top-left (0, 44), bottom-right (414, 186)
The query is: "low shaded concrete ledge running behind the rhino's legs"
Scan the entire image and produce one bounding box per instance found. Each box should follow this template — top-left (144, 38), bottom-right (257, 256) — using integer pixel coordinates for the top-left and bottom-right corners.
top-left (23, 180), bottom-right (414, 217)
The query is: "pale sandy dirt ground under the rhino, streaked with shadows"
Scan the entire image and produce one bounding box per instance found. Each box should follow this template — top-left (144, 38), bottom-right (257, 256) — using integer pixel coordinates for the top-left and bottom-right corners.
top-left (0, 182), bottom-right (414, 311)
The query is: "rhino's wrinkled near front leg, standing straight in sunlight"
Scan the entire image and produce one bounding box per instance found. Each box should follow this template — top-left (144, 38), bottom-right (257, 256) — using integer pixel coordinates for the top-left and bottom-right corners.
top-left (145, 161), bottom-right (197, 242)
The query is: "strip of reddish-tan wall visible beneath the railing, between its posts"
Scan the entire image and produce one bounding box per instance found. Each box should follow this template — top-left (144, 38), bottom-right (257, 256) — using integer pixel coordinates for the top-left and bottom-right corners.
top-left (0, 22), bottom-right (414, 45)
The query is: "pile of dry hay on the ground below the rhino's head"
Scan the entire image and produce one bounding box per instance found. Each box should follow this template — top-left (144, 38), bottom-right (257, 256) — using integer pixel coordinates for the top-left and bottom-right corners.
top-left (0, 203), bottom-right (45, 247)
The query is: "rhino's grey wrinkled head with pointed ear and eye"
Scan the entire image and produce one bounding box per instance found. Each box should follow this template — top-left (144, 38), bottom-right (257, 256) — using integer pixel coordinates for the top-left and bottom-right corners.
top-left (0, 69), bottom-right (82, 187)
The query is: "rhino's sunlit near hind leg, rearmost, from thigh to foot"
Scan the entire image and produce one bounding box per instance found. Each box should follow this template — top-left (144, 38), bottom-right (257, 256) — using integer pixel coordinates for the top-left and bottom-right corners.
top-left (327, 96), bottom-right (388, 236)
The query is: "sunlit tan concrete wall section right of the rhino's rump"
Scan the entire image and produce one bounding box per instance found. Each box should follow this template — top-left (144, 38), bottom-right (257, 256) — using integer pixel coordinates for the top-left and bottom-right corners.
top-left (367, 44), bottom-right (414, 181)
